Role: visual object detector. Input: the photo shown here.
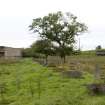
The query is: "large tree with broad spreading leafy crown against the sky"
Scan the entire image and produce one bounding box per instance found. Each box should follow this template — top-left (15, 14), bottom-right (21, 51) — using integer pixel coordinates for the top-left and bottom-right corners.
top-left (29, 12), bottom-right (87, 61)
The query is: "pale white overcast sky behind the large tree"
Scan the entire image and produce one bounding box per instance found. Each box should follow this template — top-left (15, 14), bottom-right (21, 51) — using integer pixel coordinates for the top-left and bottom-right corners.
top-left (0, 0), bottom-right (105, 50)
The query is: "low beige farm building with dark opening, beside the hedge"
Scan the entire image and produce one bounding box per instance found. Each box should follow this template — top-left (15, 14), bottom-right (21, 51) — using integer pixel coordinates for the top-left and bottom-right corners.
top-left (0, 46), bottom-right (22, 58)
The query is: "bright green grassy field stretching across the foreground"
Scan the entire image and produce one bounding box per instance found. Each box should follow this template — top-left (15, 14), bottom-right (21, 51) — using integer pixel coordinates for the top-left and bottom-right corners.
top-left (0, 56), bottom-right (105, 105)
